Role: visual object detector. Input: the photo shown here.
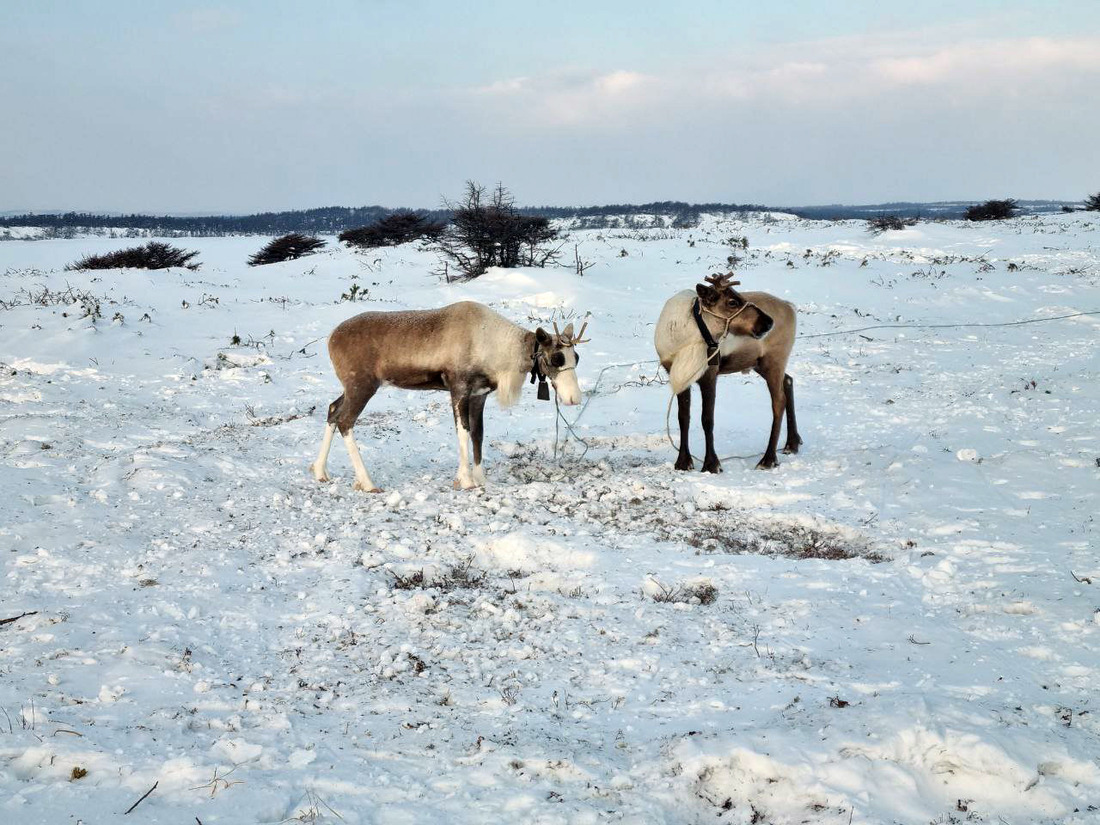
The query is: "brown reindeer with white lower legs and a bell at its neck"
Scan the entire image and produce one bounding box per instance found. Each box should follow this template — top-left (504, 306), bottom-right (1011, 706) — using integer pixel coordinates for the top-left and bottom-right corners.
top-left (309, 301), bottom-right (587, 493)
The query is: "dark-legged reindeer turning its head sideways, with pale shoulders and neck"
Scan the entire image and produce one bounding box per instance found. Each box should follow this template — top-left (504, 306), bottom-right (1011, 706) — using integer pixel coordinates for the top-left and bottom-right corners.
top-left (653, 273), bottom-right (802, 473)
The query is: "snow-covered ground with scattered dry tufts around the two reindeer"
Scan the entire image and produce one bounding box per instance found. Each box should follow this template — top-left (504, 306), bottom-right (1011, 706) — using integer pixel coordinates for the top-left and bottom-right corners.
top-left (0, 215), bottom-right (1100, 825)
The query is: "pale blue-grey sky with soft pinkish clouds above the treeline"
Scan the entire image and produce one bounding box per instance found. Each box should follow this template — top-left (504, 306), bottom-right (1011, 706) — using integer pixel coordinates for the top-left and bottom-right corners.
top-left (0, 0), bottom-right (1100, 213)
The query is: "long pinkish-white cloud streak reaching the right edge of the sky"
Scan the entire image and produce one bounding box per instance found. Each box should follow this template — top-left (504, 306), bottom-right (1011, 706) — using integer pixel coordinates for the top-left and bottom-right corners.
top-left (462, 32), bottom-right (1100, 130)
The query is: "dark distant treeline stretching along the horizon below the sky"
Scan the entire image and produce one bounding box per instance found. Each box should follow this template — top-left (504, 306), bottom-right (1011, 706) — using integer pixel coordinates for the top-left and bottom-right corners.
top-left (0, 200), bottom-right (1068, 237)
